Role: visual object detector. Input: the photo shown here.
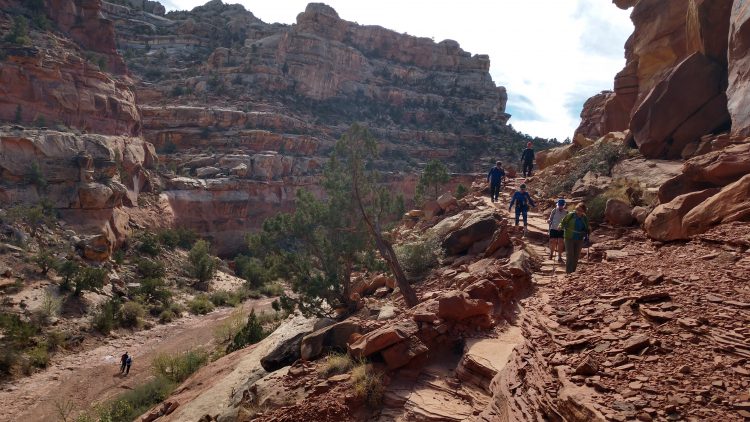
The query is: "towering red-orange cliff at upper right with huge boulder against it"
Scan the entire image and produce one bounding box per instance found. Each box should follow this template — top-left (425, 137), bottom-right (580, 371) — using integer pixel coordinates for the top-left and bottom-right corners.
top-left (577, 0), bottom-right (750, 158)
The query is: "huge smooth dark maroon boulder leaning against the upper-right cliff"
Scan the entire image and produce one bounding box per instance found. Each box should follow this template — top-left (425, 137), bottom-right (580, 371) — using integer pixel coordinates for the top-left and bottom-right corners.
top-left (630, 53), bottom-right (729, 158)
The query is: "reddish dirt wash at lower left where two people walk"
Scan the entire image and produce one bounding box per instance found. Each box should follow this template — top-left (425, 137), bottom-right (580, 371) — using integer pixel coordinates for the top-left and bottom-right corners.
top-left (0, 299), bottom-right (273, 422)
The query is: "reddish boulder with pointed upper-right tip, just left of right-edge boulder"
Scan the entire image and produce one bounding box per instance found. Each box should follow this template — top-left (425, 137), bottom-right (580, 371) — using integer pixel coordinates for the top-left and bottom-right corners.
top-left (644, 188), bottom-right (719, 241)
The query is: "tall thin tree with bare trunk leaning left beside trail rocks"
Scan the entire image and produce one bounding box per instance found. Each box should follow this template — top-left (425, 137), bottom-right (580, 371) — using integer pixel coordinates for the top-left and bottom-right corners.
top-left (323, 123), bottom-right (418, 308)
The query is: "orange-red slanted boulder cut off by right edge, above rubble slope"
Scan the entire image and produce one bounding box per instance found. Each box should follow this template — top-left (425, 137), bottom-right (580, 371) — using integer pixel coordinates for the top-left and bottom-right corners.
top-left (682, 174), bottom-right (750, 236)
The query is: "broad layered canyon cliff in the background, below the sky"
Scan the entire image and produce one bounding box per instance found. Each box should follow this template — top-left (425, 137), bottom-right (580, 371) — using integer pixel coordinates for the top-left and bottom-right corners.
top-left (98, 0), bottom-right (541, 253)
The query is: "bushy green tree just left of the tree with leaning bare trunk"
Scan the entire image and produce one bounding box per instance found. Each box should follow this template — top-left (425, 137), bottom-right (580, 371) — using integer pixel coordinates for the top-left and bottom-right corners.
top-left (243, 190), bottom-right (368, 316)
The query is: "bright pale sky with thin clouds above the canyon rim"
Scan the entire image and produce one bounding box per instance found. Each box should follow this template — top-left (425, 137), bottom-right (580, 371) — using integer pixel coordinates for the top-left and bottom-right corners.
top-left (160, 0), bottom-right (633, 140)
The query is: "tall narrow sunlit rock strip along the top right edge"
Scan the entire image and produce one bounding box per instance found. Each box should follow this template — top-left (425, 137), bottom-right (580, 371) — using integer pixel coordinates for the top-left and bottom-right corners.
top-left (727, 0), bottom-right (750, 136)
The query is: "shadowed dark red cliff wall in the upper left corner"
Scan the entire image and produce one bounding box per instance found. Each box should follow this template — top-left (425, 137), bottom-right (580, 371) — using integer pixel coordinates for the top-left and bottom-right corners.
top-left (0, 1), bottom-right (141, 136)
